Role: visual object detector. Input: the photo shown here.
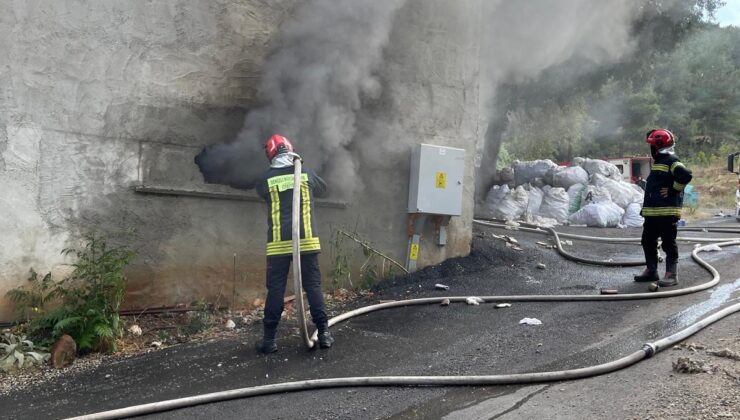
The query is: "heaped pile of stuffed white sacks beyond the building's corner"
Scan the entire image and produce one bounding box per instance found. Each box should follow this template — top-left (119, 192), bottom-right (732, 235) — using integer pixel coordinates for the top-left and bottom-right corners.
top-left (477, 158), bottom-right (644, 227)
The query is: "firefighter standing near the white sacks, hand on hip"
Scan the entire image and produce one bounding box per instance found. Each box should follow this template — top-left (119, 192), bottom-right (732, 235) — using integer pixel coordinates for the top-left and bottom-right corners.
top-left (635, 128), bottom-right (692, 287)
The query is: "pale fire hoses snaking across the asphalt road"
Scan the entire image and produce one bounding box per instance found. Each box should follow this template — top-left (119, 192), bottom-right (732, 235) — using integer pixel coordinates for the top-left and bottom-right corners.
top-left (68, 221), bottom-right (740, 419)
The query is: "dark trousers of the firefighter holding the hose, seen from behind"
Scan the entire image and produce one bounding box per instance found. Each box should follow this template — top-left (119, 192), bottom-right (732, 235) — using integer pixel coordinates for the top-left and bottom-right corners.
top-left (263, 253), bottom-right (327, 330)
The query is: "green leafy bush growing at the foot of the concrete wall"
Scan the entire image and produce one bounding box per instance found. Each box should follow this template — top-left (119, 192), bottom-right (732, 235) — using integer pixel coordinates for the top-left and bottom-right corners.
top-left (8, 234), bottom-right (134, 353)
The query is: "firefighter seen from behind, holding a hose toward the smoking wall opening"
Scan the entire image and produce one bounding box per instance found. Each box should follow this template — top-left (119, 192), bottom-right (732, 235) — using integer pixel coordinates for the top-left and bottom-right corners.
top-left (257, 134), bottom-right (334, 353)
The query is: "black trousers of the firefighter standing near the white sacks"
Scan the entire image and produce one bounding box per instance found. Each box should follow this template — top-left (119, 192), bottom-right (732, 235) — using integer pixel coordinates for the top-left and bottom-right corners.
top-left (641, 216), bottom-right (678, 273)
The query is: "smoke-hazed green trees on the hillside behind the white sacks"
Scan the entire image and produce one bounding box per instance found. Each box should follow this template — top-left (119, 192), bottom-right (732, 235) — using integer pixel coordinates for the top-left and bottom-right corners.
top-left (497, 0), bottom-right (740, 165)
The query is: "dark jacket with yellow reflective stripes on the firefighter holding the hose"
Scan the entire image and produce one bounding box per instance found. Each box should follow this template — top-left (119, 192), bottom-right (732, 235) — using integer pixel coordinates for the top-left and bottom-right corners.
top-left (257, 166), bottom-right (326, 257)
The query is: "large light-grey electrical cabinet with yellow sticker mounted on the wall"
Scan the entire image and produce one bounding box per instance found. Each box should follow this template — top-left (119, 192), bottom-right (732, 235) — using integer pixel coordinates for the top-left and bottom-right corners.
top-left (409, 144), bottom-right (465, 216)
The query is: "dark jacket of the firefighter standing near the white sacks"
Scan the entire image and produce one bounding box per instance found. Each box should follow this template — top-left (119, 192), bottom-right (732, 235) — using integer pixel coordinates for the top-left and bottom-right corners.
top-left (642, 154), bottom-right (692, 217)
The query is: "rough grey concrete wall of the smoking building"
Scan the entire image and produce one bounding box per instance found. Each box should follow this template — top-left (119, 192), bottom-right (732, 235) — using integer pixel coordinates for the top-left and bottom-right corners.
top-left (0, 0), bottom-right (481, 320)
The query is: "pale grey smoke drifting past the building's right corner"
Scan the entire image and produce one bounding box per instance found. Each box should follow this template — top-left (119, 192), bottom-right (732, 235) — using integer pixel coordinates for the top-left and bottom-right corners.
top-left (476, 0), bottom-right (640, 197)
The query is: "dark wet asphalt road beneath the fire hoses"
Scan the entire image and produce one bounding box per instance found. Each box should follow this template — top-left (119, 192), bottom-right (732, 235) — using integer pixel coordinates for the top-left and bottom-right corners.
top-left (0, 224), bottom-right (740, 419)
